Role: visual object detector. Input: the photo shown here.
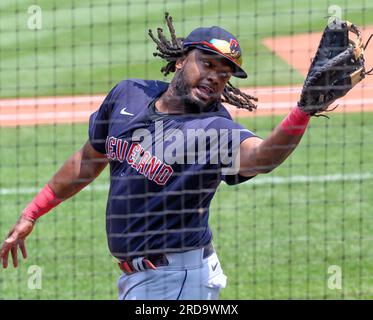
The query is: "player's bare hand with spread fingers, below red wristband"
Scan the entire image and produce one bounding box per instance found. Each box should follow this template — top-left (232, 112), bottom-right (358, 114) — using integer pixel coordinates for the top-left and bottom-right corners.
top-left (0, 217), bottom-right (35, 269)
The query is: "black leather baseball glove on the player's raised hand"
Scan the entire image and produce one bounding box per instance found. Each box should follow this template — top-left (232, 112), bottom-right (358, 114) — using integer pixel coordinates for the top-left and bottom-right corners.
top-left (298, 20), bottom-right (370, 115)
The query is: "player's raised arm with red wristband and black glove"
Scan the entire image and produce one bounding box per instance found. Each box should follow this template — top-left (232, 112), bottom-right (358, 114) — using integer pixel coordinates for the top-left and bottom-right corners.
top-left (239, 20), bottom-right (369, 177)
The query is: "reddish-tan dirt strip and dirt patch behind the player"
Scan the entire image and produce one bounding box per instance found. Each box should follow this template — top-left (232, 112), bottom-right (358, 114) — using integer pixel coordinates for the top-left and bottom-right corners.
top-left (0, 26), bottom-right (373, 127)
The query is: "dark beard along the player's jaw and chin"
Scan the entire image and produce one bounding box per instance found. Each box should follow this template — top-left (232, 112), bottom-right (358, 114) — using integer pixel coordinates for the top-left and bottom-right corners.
top-left (174, 70), bottom-right (219, 113)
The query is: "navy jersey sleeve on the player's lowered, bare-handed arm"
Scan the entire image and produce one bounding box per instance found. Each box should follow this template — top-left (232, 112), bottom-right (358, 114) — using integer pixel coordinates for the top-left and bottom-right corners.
top-left (88, 85), bottom-right (118, 154)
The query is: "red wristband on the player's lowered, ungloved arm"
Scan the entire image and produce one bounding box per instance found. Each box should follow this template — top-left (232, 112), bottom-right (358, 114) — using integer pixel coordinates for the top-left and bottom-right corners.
top-left (22, 184), bottom-right (62, 221)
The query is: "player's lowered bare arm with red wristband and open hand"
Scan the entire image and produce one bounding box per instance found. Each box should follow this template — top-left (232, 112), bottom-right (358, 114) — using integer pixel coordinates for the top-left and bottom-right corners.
top-left (0, 141), bottom-right (108, 268)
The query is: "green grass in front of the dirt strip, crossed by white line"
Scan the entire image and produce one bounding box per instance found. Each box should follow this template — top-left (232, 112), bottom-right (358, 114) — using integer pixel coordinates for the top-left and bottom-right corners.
top-left (0, 114), bottom-right (373, 299)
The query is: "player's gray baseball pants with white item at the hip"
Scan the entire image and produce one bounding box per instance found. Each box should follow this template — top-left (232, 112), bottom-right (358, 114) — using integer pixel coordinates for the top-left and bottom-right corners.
top-left (118, 248), bottom-right (227, 300)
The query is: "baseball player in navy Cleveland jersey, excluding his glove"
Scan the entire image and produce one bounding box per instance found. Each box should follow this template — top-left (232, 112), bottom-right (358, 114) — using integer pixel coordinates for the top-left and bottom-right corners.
top-left (0, 14), bottom-right (364, 300)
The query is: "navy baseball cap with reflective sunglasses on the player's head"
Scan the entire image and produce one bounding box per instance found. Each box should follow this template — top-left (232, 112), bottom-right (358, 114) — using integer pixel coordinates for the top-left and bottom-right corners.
top-left (183, 26), bottom-right (247, 78)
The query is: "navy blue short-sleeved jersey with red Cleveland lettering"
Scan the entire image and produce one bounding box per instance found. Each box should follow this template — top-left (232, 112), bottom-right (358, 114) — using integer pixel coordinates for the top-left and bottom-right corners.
top-left (89, 79), bottom-right (254, 259)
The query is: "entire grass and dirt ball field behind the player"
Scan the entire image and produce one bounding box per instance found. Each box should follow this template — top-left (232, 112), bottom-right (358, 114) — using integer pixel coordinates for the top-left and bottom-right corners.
top-left (0, 0), bottom-right (373, 299)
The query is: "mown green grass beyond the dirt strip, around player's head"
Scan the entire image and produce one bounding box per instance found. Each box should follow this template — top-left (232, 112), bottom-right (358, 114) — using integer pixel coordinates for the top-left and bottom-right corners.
top-left (0, 0), bottom-right (373, 97)
